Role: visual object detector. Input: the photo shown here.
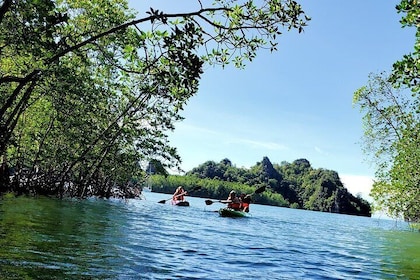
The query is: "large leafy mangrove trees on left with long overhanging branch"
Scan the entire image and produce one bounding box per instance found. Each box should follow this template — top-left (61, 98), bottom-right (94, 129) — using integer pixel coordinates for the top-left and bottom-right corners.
top-left (0, 0), bottom-right (309, 197)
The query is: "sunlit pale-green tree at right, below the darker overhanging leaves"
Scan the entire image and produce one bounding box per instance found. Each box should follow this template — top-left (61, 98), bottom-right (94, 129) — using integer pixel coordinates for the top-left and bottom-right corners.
top-left (354, 73), bottom-right (420, 221)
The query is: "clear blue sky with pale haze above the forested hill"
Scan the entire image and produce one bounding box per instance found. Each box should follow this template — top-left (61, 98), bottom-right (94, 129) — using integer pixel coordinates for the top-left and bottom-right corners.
top-left (130, 0), bottom-right (415, 197)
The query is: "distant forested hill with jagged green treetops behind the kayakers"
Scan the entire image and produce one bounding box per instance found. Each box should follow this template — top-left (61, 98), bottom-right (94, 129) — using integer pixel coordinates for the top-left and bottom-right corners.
top-left (151, 157), bottom-right (371, 217)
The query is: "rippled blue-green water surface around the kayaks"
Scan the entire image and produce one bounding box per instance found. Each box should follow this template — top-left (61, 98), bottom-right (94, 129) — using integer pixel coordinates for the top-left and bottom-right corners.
top-left (0, 193), bottom-right (420, 279)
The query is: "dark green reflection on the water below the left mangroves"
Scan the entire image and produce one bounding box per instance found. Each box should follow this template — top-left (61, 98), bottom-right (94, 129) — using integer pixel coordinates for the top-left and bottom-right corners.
top-left (0, 197), bottom-right (128, 279)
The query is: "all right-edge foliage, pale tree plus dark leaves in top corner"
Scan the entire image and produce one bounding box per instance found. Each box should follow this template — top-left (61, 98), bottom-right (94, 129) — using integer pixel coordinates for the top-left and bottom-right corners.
top-left (354, 0), bottom-right (420, 222)
